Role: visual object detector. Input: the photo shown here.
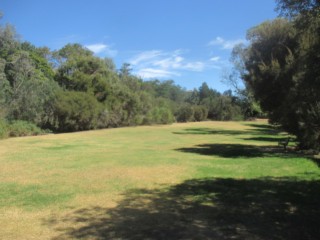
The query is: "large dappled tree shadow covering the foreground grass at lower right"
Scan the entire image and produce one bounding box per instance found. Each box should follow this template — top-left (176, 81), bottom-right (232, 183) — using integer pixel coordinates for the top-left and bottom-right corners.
top-left (45, 178), bottom-right (320, 240)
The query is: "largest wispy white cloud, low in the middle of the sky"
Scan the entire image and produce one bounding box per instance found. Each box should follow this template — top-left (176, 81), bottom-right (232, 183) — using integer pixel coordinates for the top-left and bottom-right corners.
top-left (129, 49), bottom-right (207, 78)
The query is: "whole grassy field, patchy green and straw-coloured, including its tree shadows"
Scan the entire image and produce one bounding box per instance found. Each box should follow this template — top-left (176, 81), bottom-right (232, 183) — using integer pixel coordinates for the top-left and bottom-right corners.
top-left (0, 121), bottom-right (320, 240)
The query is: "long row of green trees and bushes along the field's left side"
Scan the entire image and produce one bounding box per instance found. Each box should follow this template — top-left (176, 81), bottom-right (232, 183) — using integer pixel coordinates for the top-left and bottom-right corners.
top-left (0, 15), bottom-right (254, 137)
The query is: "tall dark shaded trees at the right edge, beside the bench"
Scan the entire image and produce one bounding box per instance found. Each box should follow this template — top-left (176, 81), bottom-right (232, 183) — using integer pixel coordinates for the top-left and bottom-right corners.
top-left (229, 0), bottom-right (320, 150)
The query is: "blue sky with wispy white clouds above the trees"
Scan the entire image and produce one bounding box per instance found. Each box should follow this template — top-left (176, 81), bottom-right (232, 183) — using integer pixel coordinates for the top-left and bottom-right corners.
top-left (0, 0), bottom-right (277, 91)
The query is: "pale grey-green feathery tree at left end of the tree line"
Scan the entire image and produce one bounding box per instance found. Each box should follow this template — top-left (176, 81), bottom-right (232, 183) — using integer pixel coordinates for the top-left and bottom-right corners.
top-left (6, 51), bottom-right (57, 126)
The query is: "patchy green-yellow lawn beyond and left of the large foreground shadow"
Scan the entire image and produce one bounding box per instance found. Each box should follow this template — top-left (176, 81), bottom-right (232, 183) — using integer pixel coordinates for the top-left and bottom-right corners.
top-left (0, 121), bottom-right (320, 239)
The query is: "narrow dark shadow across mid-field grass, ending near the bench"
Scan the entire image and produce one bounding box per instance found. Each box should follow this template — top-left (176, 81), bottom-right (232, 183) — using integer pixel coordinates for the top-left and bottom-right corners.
top-left (176, 143), bottom-right (298, 158)
